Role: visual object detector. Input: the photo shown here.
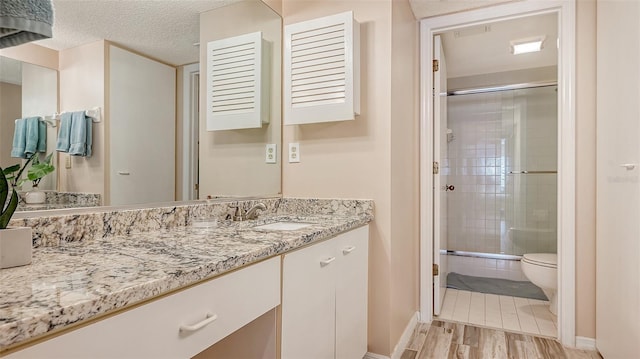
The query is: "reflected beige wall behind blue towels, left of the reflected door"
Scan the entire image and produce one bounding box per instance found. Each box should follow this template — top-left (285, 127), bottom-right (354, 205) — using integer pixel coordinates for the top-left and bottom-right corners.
top-left (59, 40), bottom-right (108, 198)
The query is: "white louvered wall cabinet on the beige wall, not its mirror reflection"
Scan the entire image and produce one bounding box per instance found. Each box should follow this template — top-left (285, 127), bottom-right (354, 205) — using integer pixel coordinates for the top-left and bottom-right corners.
top-left (284, 11), bottom-right (360, 125)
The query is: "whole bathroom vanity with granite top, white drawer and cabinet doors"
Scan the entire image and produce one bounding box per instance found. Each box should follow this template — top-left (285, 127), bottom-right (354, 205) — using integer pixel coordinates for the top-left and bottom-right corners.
top-left (0, 199), bottom-right (373, 358)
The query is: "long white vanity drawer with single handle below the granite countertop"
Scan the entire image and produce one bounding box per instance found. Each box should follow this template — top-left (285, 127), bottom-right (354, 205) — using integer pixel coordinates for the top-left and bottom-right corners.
top-left (9, 257), bottom-right (280, 358)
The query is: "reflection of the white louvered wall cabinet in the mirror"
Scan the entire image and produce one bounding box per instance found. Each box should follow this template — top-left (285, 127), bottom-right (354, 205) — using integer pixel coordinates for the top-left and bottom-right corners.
top-left (207, 32), bottom-right (269, 131)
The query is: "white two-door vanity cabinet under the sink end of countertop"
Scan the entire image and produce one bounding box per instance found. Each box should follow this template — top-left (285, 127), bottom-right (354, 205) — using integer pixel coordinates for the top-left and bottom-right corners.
top-left (281, 225), bottom-right (369, 359)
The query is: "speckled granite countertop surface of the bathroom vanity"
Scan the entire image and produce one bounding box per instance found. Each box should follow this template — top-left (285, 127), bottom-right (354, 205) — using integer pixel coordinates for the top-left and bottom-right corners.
top-left (0, 214), bottom-right (373, 352)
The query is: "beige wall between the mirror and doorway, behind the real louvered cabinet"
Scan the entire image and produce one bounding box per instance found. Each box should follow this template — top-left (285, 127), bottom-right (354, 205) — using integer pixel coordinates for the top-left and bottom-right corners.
top-left (283, 0), bottom-right (418, 355)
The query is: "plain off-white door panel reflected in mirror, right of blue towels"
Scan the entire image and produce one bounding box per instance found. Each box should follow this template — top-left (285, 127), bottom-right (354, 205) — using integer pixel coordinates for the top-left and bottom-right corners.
top-left (109, 46), bottom-right (176, 205)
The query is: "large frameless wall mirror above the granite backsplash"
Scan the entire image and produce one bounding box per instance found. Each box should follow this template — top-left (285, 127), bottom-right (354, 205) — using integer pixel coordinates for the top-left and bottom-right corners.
top-left (0, 0), bottom-right (282, 211)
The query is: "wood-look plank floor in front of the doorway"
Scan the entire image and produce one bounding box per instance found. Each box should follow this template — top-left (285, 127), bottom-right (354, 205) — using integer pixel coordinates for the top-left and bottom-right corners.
top-left (401, 320), bottom-right (602, 359)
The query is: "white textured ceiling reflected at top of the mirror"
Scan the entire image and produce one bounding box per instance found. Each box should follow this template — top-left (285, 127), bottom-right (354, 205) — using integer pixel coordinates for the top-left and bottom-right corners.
top-left (37, 0), bottom-right (244, 65)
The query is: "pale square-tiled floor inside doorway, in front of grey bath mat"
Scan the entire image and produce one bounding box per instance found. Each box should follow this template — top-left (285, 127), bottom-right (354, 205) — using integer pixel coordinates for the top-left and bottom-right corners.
top-left (438, 288), bottom-right (558, 338)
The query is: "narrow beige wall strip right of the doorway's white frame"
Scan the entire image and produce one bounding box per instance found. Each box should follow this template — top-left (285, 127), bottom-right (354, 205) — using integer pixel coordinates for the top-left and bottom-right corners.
top-left (576, 0), bottom-right (596, 338)
